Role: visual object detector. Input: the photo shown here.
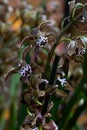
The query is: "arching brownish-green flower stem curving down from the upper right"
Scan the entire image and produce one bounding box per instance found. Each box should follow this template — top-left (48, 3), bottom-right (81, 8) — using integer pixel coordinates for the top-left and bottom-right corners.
top-left (44, 14), bottom-right (82, 78)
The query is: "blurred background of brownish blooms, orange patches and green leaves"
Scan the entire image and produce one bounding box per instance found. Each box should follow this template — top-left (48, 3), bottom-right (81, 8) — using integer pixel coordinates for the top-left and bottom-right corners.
top-left (0, 0), bottom-right (87, 130)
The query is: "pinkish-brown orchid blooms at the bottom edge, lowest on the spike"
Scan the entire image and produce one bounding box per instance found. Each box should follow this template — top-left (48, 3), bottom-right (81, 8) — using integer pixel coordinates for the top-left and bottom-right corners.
top-left (20, 102), bottom-right (58, 130)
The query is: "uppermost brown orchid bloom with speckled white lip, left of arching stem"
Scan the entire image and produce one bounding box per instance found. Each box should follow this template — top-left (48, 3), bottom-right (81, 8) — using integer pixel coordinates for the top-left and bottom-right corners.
top-left (21, 21), bottom-right (56, 47)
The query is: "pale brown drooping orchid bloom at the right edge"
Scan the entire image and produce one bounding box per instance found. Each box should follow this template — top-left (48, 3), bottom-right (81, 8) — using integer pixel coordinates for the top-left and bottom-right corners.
top-left (67, 36), bottom-right (87, 62)
